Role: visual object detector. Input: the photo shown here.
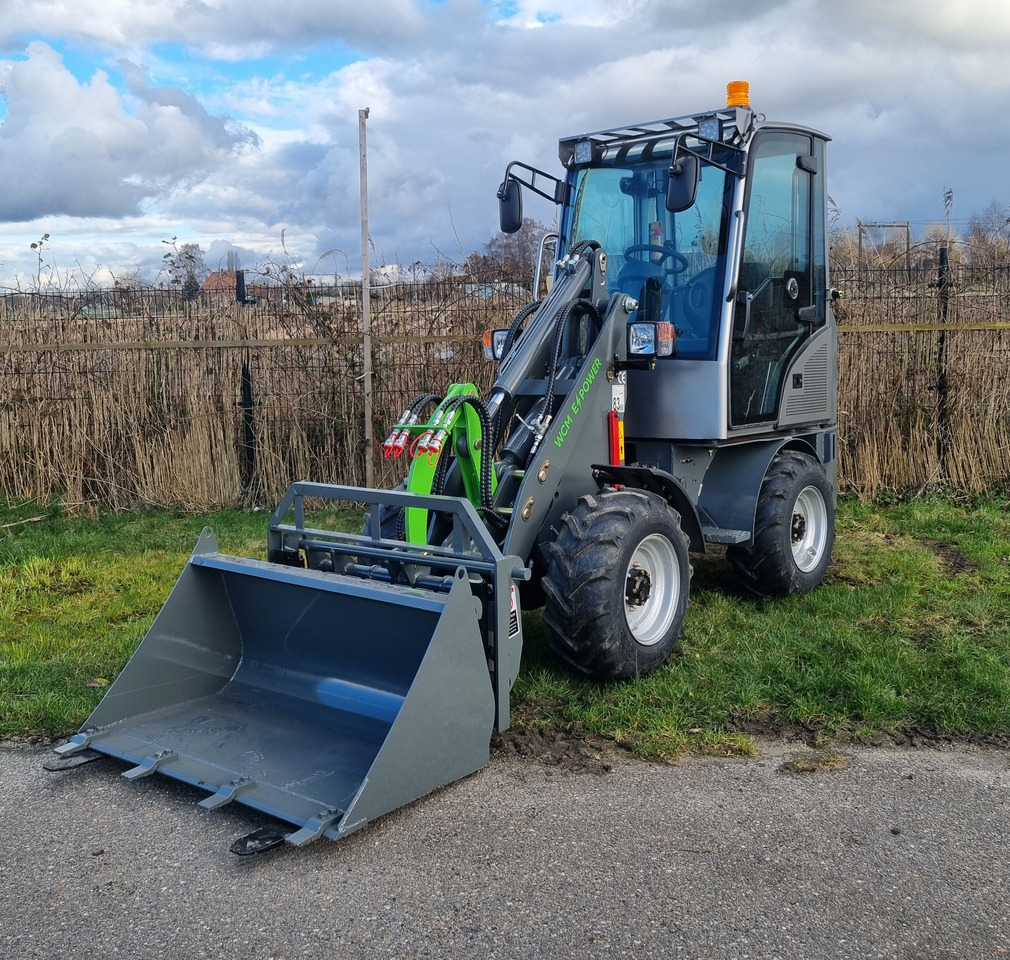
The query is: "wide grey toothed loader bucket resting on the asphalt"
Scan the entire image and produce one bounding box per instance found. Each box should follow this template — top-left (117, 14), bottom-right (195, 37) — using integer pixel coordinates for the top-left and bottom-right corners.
top-left (58, 531), bottom-right (495, 845)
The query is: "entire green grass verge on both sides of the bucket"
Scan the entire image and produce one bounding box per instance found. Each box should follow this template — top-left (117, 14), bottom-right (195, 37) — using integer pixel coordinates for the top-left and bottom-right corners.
top-left (0, 499), bottom-right (1010, 759)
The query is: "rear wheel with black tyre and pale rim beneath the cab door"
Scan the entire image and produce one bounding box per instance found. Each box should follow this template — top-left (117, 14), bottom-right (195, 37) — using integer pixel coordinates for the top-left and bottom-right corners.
top-left (726, 450), bottom-right (834, 596)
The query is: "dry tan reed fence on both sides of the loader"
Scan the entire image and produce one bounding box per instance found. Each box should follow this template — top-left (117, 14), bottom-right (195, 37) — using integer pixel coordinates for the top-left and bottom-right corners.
top-left (0, 265), bottom-right (1010, 509)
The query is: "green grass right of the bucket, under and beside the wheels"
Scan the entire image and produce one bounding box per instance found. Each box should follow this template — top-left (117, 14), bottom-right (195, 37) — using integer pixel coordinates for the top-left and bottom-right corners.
top-left (514, 500), bottom-right (1010, 758)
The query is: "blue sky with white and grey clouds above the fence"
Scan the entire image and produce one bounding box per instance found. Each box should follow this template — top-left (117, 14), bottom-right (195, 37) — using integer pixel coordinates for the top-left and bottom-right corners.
top-left (0, 0), bottom-right (1010, 288)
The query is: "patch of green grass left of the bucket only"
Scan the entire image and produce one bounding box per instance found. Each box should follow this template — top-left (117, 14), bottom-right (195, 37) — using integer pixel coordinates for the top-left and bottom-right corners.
top-left (0, 503), bottom-right (267, 736)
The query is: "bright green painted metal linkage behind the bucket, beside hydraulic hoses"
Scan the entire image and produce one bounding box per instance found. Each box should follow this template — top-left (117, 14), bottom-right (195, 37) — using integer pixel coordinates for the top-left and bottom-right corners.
top-left (404, 383), bottom-right (497, 544)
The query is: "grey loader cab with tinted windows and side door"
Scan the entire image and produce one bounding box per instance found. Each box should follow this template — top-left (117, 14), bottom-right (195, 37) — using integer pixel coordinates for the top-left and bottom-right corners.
top-left (559, 109), bottom-right (835, 442)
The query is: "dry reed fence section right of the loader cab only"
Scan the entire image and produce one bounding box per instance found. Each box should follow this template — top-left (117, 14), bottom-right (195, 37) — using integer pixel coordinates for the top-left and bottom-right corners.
top-left (835, 257), bottom-right (1010, 495)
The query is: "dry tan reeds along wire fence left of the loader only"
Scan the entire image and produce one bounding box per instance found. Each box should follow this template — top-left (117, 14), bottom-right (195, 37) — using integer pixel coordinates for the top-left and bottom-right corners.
top-left (0, 284), bottom-right (518, 509)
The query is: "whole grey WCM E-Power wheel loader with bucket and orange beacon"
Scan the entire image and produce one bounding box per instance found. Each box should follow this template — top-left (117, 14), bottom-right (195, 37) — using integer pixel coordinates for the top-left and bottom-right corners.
top-left (53, 83), bottom-right (837, 854)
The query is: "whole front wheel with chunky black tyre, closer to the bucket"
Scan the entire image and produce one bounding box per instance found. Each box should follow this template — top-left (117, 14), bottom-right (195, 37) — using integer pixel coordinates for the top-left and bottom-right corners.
top-left (542, 489), bottom-right (691, 680)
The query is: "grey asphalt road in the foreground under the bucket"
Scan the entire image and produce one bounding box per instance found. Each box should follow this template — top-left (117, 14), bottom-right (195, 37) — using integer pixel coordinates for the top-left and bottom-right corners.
top-left (0, 744), bottom-right (1010, 960)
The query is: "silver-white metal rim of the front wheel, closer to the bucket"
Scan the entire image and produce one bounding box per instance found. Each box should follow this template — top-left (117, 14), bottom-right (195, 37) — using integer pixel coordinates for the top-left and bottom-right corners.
top-left (624, 534), bottom-right (681, 647)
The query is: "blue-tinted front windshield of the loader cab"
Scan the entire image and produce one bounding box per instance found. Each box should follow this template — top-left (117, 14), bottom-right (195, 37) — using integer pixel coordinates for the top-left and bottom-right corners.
top-left (568, 156), bottom-right (731, 359)
